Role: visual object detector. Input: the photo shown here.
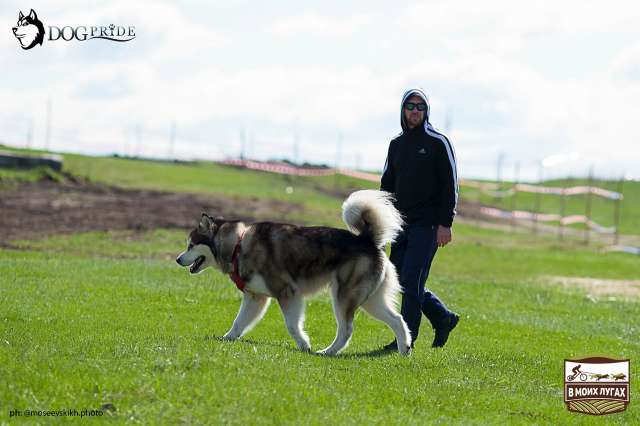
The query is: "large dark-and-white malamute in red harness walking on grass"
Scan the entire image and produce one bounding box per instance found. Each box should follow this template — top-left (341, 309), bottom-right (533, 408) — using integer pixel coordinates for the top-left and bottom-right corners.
top-left (176, 190), bottom-right (411, 355)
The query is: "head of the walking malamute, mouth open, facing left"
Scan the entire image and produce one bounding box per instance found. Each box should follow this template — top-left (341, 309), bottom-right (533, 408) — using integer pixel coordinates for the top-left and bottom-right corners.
top-left (176, 213), bottom-right (221, 274)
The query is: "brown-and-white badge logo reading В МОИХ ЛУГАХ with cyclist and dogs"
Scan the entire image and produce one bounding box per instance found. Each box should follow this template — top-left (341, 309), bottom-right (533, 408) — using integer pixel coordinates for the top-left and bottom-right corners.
top-left (564, 357), bottom-right (629, 415)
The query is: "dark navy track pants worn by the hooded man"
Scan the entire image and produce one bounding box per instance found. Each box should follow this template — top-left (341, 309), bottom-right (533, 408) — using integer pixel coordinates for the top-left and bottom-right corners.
top-left (390, 225), bottom-right (452, 342)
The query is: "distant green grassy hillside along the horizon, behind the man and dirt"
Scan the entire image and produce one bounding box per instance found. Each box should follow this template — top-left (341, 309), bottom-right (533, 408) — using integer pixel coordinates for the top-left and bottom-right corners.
top-left (0, 147), bottom-right (640, 235)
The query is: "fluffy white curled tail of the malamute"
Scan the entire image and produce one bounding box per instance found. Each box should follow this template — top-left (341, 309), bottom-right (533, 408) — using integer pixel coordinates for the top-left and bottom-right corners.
top-left (342, 190), bottom-right (403, 248)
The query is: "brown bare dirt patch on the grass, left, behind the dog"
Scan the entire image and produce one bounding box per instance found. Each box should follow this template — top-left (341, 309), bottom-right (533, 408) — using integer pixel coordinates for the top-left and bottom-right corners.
top-left (0, 180), bottom-right (303, 243)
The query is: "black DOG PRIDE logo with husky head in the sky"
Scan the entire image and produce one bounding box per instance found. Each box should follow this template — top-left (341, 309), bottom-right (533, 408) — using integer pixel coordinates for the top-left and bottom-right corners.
top-left (12, 9), bottom-right (136, 50)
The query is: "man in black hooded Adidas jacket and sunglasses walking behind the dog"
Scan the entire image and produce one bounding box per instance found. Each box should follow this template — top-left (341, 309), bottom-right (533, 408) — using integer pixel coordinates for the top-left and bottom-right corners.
top-left (380, 89), bottom-right (460, 349)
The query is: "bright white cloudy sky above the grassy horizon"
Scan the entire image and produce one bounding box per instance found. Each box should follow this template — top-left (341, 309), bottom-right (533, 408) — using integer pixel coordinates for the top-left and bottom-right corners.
top-left (0, 0), bottom-right (640, 179)
